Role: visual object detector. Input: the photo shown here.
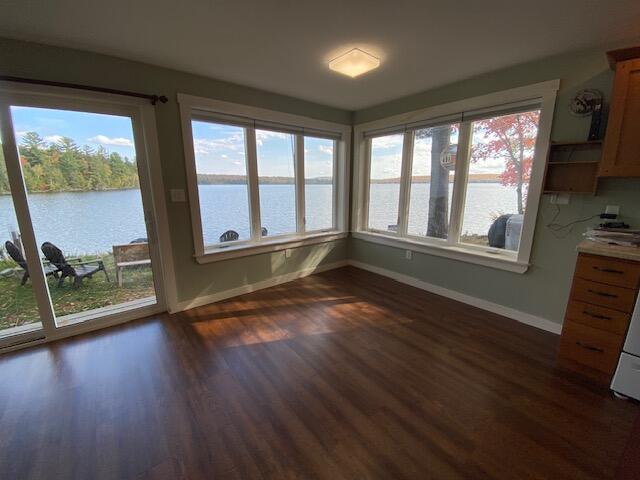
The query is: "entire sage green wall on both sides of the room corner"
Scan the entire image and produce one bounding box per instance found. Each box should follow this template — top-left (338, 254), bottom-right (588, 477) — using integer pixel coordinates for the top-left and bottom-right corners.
top-left (5, 39), bottom-right (640, 323)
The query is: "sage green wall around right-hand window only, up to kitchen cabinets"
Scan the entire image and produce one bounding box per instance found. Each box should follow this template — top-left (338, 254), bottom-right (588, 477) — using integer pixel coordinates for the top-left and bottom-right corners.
top-left (348, 46), bottom-right (640, 323)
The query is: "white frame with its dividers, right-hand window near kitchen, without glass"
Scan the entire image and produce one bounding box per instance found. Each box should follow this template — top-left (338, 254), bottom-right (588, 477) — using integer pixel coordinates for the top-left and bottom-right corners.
top-left (351, 80), bottom-right (560, 273)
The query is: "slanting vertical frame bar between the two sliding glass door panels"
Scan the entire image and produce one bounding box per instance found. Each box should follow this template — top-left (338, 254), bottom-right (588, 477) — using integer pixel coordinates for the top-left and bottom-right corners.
top-left (0, 103), bottom-right (56, 336)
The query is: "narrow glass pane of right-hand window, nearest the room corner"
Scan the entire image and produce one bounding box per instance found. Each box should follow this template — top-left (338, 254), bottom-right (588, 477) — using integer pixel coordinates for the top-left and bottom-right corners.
top-left (368, 135), bottom-right (404, 231)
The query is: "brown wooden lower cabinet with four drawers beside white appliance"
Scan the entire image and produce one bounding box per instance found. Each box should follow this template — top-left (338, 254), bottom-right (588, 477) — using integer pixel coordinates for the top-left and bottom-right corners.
top-left (558, 253), bottom-right (640, 384)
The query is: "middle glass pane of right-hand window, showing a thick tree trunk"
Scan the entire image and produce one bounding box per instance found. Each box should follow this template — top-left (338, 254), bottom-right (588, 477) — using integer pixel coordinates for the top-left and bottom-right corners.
top-left (407, 125), bottom-right (458, 238)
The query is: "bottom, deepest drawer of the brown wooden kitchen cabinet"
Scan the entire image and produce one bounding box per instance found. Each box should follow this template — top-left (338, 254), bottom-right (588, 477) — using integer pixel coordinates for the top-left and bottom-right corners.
top-left (560, 320), bottom-right (623, 374)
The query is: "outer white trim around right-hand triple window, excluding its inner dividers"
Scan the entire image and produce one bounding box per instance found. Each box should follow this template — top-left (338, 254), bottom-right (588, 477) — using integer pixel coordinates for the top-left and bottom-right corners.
top-left (351, 80), bottom-right (560, 273)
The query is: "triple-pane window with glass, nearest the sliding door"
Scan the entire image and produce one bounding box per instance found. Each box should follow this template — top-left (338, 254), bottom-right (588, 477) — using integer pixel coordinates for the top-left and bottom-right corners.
top-left (178, 94), bottom-right (350, 262)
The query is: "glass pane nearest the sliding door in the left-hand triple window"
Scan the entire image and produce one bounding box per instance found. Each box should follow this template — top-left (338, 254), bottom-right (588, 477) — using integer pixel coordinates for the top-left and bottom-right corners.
top-left (191, 120), bottom-right (251, 245)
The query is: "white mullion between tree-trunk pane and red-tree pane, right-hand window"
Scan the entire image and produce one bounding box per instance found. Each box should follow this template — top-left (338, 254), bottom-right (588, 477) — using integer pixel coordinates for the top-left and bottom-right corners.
top-left (448, 122), bottom-right (471, 245)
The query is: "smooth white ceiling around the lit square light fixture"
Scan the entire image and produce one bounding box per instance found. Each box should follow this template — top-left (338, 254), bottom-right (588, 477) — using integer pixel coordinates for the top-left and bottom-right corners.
top-left (0, 0), bottom-right (640, 110)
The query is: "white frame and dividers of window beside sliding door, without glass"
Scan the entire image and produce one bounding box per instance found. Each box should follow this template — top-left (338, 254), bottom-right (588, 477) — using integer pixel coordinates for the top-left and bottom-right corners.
top-left (178, 93), bottom-right (351, 263)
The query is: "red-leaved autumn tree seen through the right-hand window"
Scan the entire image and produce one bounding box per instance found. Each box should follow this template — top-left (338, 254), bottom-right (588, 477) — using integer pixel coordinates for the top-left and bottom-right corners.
top-left (471, 110), bottom-right (540, 214)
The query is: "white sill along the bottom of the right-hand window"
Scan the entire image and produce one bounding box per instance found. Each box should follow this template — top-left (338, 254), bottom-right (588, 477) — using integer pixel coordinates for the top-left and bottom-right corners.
top-left (352, 232), bottom-right (529, 273)
